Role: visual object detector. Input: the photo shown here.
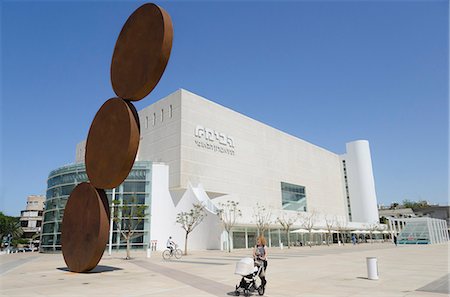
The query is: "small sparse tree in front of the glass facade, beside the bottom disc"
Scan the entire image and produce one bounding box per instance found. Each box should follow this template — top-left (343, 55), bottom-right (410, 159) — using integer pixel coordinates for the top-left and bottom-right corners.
top-left (112, 196), bottom-right (148, 260)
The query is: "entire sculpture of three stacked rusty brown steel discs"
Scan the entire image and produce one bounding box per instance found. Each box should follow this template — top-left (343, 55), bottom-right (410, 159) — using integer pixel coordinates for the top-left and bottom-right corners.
top-left (61, 3), bottom-right (173, 272)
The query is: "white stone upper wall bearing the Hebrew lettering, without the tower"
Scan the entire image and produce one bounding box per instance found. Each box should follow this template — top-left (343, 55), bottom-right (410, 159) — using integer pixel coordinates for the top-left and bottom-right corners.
top-left (138, 90), bottom-right (347, 215)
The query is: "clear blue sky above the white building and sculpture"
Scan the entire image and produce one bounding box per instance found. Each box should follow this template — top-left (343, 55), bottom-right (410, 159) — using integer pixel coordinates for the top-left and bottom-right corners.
top-left (0, 0), bottom-right (449, 215)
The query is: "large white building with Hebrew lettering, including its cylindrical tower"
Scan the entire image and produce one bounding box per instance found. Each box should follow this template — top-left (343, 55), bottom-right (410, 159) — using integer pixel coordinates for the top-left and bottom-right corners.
top-left (44, 90), bottom-right (384, 249)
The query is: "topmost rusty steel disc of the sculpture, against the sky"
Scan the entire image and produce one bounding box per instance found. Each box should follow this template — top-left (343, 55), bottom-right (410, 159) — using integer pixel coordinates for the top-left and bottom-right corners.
top-left (111, 3), bottom-right (173, 101)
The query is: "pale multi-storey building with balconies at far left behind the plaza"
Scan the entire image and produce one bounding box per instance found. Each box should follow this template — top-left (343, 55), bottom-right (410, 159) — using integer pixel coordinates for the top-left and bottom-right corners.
top-left (20, 195), bottom-right (45, 247)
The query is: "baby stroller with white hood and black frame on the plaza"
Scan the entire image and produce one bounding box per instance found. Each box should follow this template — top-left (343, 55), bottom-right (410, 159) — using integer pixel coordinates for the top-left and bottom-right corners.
top-left (234, 258), bottom-right (265, 296)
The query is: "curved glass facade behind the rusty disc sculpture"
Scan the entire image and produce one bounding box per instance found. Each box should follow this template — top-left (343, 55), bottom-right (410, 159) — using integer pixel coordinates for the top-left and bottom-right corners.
top-left (40, 161), bottom-right (152, 252)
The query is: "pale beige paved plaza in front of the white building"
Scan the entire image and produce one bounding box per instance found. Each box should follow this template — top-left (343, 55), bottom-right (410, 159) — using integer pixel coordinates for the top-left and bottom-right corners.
top-left (0, 243), bottom-right (449, 297)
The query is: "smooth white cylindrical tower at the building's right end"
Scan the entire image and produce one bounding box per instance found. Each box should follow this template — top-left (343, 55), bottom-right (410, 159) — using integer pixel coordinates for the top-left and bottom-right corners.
top-left (344, 140), bottom-right (379, 223)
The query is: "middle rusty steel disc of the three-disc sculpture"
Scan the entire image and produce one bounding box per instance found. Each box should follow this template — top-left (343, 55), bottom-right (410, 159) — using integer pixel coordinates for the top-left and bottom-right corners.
top-left (85, 98), bottom-right (140, 189)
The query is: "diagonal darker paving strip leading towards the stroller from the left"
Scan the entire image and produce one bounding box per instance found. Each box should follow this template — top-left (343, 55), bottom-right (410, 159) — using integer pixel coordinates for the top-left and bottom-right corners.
top-left (132, 260), bottom-right (234, 297)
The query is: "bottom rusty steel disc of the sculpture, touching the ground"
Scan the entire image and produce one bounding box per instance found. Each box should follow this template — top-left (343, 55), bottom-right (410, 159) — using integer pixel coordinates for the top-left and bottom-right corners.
top-left (61, 183), bottom-right (109, 272)
